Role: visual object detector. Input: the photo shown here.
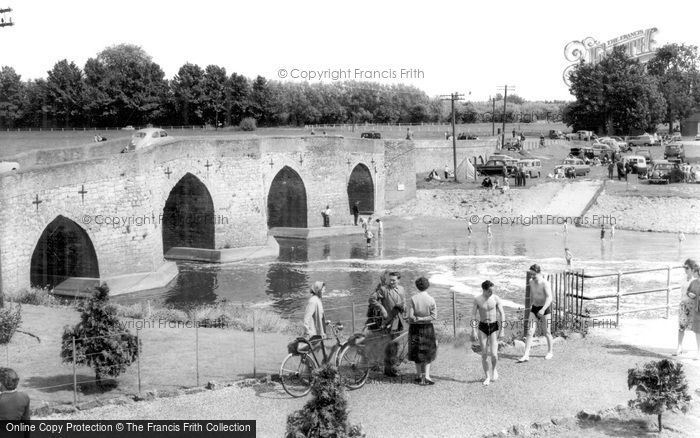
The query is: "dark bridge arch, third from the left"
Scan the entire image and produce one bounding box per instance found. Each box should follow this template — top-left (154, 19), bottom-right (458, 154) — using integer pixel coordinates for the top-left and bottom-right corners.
top-left (267, 166), bottom-right (307, 228)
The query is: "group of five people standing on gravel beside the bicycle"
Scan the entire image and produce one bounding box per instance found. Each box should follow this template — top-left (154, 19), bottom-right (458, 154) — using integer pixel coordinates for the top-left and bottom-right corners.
top-left (304, 264), bottom-right (554, 385)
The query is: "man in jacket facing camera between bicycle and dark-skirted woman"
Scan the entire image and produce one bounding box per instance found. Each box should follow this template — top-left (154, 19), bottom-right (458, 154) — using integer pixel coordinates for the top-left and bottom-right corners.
top-left (369, 272), bottom-right (406, 377)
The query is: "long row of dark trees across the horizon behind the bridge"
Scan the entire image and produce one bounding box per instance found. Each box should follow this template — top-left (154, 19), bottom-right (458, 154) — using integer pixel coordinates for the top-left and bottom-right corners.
top-left (0, 44), bottom-right (564, 129)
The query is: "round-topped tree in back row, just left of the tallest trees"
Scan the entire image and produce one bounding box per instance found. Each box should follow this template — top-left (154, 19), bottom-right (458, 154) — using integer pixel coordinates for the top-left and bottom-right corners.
top-left (46, 59), bottom-right (84, 127)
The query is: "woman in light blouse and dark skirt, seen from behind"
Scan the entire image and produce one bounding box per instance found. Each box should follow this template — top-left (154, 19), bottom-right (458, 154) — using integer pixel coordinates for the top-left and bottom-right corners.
top-left (408, 277), bottom-right (437, 385)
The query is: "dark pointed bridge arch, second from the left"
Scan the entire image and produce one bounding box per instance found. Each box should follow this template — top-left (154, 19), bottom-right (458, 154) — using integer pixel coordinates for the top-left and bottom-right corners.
top-left (162, 173), bottom-right (214, 254)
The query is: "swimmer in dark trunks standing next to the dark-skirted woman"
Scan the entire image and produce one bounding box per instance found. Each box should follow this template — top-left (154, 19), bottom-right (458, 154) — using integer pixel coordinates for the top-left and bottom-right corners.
top-left (472, 280), bottom-right (505, 385)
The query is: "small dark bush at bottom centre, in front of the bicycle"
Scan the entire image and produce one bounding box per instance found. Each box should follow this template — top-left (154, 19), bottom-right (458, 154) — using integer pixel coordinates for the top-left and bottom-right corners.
top-left (285, 364), bottom-right (365, 438)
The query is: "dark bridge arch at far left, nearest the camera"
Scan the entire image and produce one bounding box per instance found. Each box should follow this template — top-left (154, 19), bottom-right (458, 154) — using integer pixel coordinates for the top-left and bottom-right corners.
top-left (29, 216), bottom-right (100, 288)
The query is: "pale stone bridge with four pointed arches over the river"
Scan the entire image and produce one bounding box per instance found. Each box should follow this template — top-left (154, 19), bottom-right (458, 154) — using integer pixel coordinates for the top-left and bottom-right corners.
top-left (0, 137), bottom-right (394, 293)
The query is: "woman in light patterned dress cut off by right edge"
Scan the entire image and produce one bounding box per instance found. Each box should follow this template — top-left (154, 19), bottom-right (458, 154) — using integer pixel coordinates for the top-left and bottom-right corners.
top-left (674, 259), bottom-right (700, 360)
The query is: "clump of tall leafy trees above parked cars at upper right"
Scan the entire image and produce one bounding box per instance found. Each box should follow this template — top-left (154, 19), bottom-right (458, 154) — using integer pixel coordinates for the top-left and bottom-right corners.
top-left (563, 44), bottom-right (700, 135)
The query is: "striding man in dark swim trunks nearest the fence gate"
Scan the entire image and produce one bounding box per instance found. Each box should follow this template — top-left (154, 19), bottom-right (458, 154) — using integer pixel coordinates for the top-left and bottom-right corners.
top-left (517, 265), bottom-right (554, 363)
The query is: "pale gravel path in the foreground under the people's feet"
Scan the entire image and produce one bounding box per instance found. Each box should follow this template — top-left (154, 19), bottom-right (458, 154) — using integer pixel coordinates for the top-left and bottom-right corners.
top-left (46, 336), bottom-right (700, 438)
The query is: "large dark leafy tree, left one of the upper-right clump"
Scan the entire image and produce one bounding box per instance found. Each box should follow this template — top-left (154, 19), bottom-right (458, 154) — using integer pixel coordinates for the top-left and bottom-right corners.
top-left (564, 47), bottom-right (666, 134)
